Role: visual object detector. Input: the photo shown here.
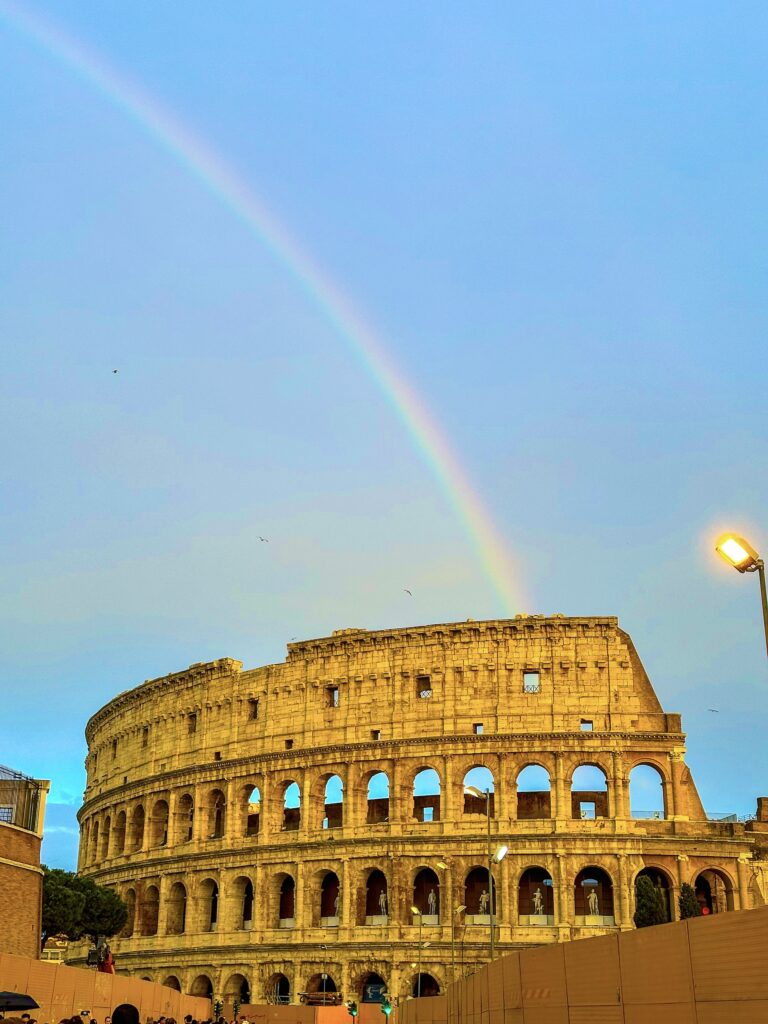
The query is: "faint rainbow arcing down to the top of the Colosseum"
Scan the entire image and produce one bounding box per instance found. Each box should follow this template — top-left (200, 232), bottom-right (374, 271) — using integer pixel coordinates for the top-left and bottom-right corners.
top-left (0, 0), bottom-right (524, 615)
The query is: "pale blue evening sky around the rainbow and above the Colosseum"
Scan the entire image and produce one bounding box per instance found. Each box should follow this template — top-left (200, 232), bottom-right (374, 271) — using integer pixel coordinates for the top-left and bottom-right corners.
top-left (0, 0), bottom-right (768, 865)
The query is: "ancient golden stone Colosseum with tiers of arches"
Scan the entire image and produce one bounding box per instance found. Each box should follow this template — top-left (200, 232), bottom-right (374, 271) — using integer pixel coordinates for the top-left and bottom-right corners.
top-left (79, 615), bottom-right (768, 1002)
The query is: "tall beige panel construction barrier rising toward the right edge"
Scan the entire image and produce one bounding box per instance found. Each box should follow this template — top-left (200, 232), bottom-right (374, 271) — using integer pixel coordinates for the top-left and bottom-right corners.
top-left (394, 907), bottom-right (768, 1024)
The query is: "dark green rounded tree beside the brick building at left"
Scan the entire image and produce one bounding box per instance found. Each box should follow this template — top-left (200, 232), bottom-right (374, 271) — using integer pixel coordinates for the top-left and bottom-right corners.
top-left (43, 865), bottom-right (128, 946)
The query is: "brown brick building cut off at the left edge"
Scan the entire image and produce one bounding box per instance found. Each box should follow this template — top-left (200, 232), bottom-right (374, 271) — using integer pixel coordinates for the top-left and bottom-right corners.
top-left (0, 766), bottom-right (50, 956)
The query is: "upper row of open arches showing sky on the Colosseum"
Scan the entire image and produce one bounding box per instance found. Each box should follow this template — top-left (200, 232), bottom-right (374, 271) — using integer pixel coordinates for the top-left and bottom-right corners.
top-left (81, 762), bottom-right (667, 866)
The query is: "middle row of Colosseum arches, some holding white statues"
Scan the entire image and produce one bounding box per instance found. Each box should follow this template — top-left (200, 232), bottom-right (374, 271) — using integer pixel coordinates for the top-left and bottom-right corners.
top-left (123, 865), bottom-right (734, 937)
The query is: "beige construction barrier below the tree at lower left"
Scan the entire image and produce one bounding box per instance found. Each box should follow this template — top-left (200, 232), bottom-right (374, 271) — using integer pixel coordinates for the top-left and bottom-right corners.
top-left (0, 953), bottom-right (212, 1024)
